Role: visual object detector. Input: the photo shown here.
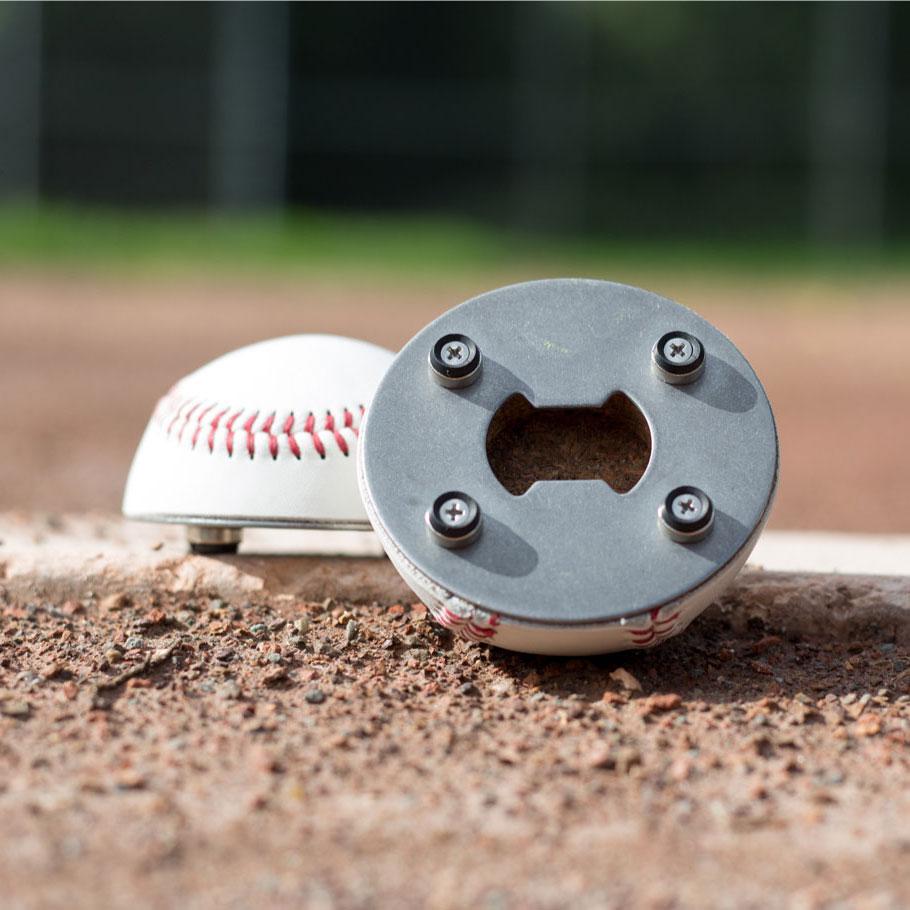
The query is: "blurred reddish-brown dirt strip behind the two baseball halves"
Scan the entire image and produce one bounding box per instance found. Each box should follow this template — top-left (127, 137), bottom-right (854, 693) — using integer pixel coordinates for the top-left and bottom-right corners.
top-left (0, 272), bottom-right (910, 532)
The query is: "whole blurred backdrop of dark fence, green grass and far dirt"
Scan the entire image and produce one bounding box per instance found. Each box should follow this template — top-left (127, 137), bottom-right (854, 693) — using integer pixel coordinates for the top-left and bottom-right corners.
top-left (0, 2), bottom-right (910, 532)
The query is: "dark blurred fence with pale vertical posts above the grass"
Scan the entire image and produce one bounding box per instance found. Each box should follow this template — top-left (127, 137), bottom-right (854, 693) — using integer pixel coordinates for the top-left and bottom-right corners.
top-left (0, 3), bottom-right (910, 243)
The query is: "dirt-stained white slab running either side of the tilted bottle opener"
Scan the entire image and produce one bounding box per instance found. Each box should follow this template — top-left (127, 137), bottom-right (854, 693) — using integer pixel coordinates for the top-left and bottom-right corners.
top-left (0, 514), bottom-right (910, 641)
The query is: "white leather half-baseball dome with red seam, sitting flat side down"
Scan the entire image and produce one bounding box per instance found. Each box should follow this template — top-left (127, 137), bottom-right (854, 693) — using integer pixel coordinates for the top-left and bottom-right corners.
top-left (123, 335), bottom-right (393, 528)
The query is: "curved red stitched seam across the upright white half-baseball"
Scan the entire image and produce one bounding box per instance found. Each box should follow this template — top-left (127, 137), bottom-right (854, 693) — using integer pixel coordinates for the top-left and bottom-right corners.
top-left (155, 390), bottom-right (366, 460)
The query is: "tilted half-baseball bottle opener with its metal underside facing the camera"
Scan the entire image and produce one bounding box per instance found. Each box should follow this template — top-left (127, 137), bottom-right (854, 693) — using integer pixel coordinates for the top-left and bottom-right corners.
top-left (358, 279), bottom-right (778, 654)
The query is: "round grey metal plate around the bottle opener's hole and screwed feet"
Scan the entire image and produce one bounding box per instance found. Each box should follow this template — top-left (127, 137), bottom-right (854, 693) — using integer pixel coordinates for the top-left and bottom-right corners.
top-left (360, 279), bottom-right (778, 626)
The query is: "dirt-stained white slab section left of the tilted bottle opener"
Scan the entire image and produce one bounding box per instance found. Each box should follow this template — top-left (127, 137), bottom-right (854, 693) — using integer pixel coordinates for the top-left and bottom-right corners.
top-left (0, 513), bottom-right (400, 603)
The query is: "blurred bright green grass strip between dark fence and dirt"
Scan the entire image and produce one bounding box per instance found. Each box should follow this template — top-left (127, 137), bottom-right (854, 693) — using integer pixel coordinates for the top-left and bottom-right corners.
top-left (0, 206), bottom-right (910, 280)
